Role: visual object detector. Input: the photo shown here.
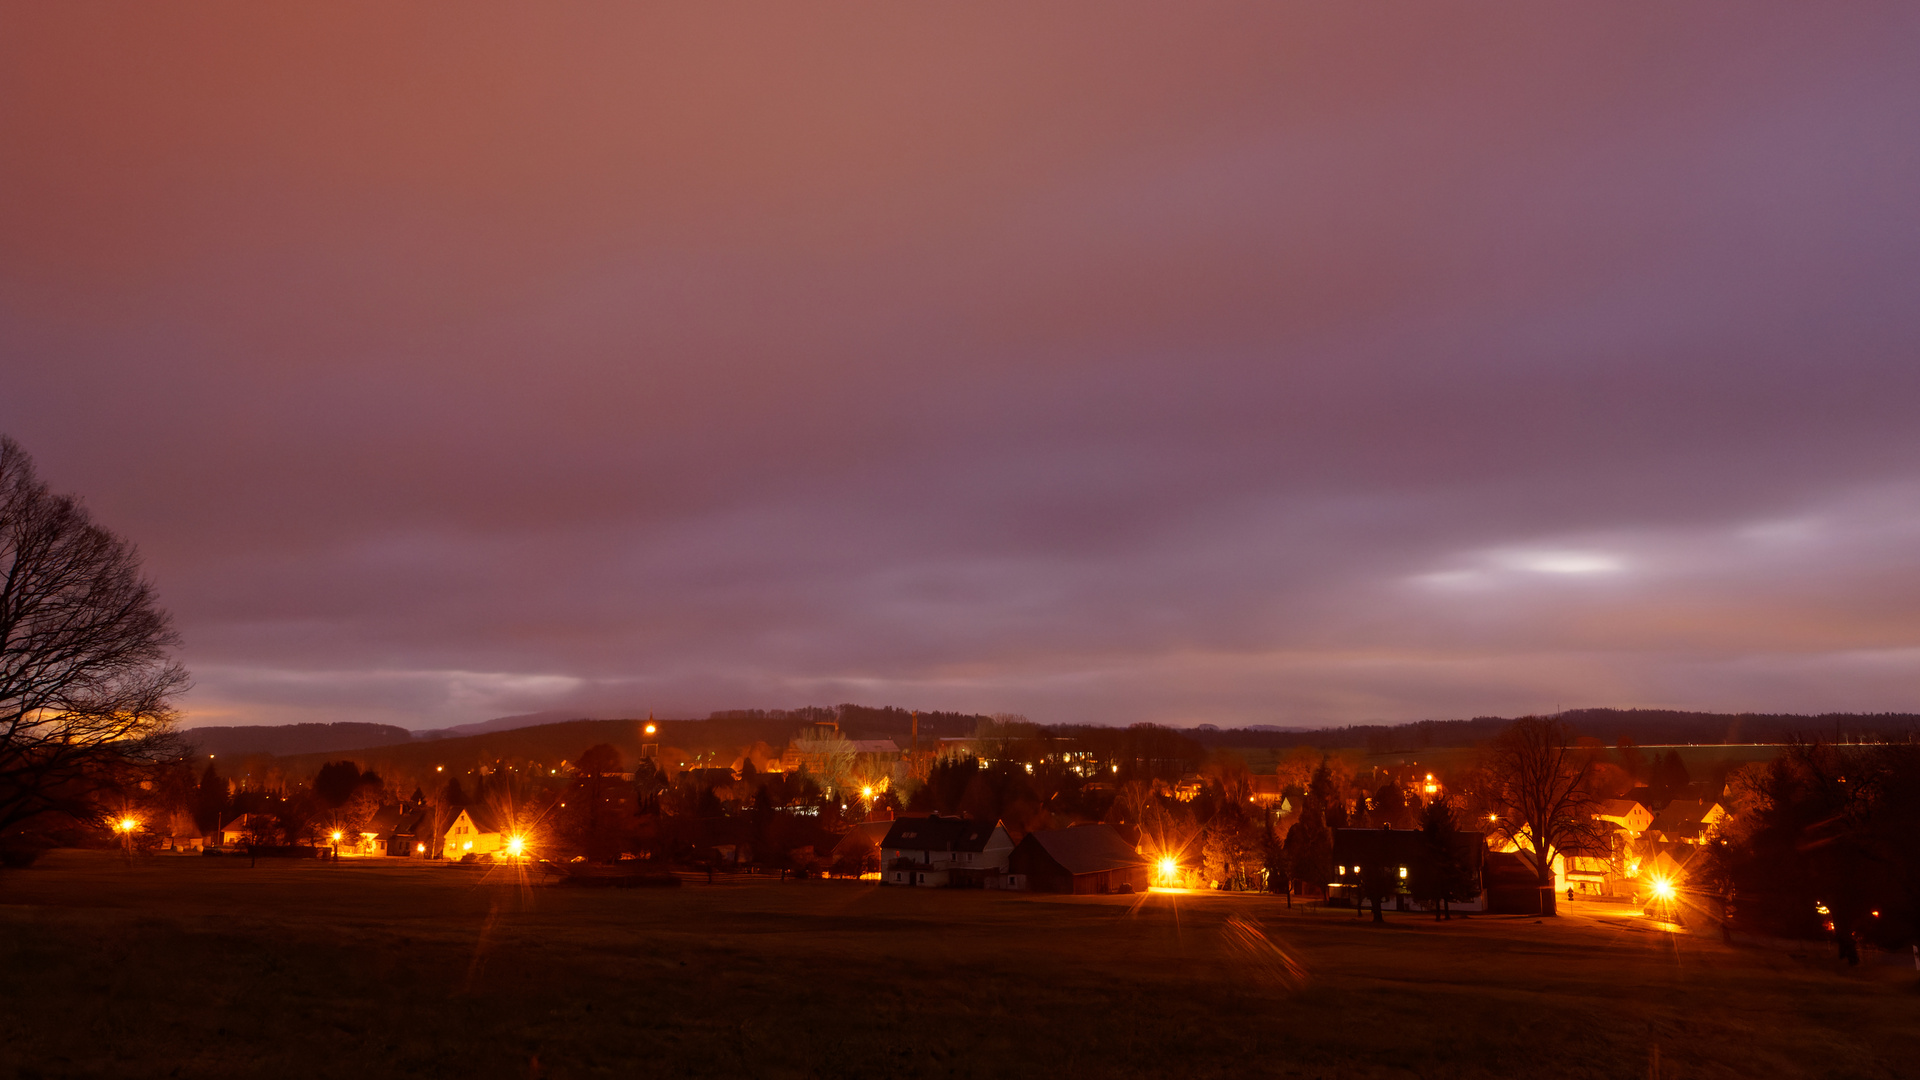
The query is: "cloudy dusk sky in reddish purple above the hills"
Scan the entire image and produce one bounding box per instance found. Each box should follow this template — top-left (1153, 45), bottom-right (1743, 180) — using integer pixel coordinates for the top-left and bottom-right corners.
top-left (0, 2), bottom-right (1920, 728)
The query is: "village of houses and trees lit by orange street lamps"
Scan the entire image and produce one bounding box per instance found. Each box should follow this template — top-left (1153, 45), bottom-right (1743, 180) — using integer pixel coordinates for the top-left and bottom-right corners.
top-left (121, 717), bottom-right (1781, 922)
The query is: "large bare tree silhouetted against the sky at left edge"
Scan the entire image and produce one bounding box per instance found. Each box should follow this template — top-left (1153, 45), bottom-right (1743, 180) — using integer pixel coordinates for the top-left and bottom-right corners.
top-left (0, 436), bottom-right (186, 836)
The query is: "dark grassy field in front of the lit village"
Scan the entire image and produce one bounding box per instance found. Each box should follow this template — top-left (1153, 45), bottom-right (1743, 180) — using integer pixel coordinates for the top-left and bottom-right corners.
top-left (0, 851), bottom-right (1920, 1080)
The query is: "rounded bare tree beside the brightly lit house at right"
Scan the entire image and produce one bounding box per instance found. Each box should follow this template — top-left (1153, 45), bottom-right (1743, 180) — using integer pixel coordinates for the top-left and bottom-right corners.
top-left (1486, 717), bottom-right (1601, 915)
